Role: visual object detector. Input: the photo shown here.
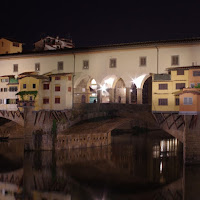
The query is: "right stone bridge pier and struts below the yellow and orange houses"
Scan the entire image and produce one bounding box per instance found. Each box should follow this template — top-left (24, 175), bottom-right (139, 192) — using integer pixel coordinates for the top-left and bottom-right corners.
top-left (153, 113), bottom-right (200, 164)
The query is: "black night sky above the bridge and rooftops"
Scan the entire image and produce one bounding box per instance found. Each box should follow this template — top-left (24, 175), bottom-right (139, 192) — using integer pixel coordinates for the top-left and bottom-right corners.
top-left (0, 0), bottom-right (200, 47)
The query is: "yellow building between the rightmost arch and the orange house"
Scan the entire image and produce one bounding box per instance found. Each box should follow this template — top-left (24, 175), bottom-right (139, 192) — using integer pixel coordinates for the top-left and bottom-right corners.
top-left (152, 67), bottom-right (189, 112)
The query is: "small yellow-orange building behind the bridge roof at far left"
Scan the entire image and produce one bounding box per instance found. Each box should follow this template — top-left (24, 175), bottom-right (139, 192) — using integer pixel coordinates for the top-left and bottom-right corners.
top-left (0, 37), bottom-right (22, 54)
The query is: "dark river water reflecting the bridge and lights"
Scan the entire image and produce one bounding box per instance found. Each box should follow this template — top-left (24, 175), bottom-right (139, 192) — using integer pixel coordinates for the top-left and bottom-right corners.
top-left (0, 131), bottom-right (200, 200)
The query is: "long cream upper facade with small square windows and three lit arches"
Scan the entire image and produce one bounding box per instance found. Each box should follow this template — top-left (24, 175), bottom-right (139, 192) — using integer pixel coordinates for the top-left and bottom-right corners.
top-left (0, 38), bottom-right (200, 108)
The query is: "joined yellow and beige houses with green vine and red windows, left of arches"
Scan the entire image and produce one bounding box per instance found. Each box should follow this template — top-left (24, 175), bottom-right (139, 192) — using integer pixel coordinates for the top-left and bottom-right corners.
top-left (18, 73), bottom-right (72, 111)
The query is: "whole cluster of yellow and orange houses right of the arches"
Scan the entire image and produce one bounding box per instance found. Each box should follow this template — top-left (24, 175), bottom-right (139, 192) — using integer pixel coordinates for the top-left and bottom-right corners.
top-left (152, 66), bottom-right (200, 115)
